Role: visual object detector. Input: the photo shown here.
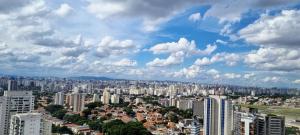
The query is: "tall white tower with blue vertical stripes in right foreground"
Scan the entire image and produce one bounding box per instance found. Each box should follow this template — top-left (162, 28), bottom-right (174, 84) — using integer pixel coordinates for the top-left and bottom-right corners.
top-left (203, 95), bottom-right (232, 135)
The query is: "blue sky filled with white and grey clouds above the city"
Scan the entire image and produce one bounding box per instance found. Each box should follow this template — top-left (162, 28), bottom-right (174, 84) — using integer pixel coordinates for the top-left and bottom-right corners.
top-left (0, 0), bottom-right (300, 88)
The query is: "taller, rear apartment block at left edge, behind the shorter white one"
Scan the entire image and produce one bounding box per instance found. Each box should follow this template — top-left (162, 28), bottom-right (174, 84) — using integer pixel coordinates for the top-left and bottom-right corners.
top-left (0, 91), bottom-right (34, 135)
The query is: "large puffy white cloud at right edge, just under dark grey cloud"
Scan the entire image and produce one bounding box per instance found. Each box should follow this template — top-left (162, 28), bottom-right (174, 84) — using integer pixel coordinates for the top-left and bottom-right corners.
top-left (239, 10), bottom-right (300, 48)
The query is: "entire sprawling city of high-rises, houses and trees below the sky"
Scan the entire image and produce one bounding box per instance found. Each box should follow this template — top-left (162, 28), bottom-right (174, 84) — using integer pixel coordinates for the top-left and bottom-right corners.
top-left (0, 77), bottom-right (300, 135)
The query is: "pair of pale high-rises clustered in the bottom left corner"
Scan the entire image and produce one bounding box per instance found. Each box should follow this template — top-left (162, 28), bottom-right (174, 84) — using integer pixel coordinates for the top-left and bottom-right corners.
top-left (0, 89), bottom-right (51, 135)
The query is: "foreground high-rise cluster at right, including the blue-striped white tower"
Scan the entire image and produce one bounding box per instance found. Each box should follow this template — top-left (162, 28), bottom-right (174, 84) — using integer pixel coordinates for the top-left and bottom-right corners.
top-left (203, 95), bottom-right (285, 135)
